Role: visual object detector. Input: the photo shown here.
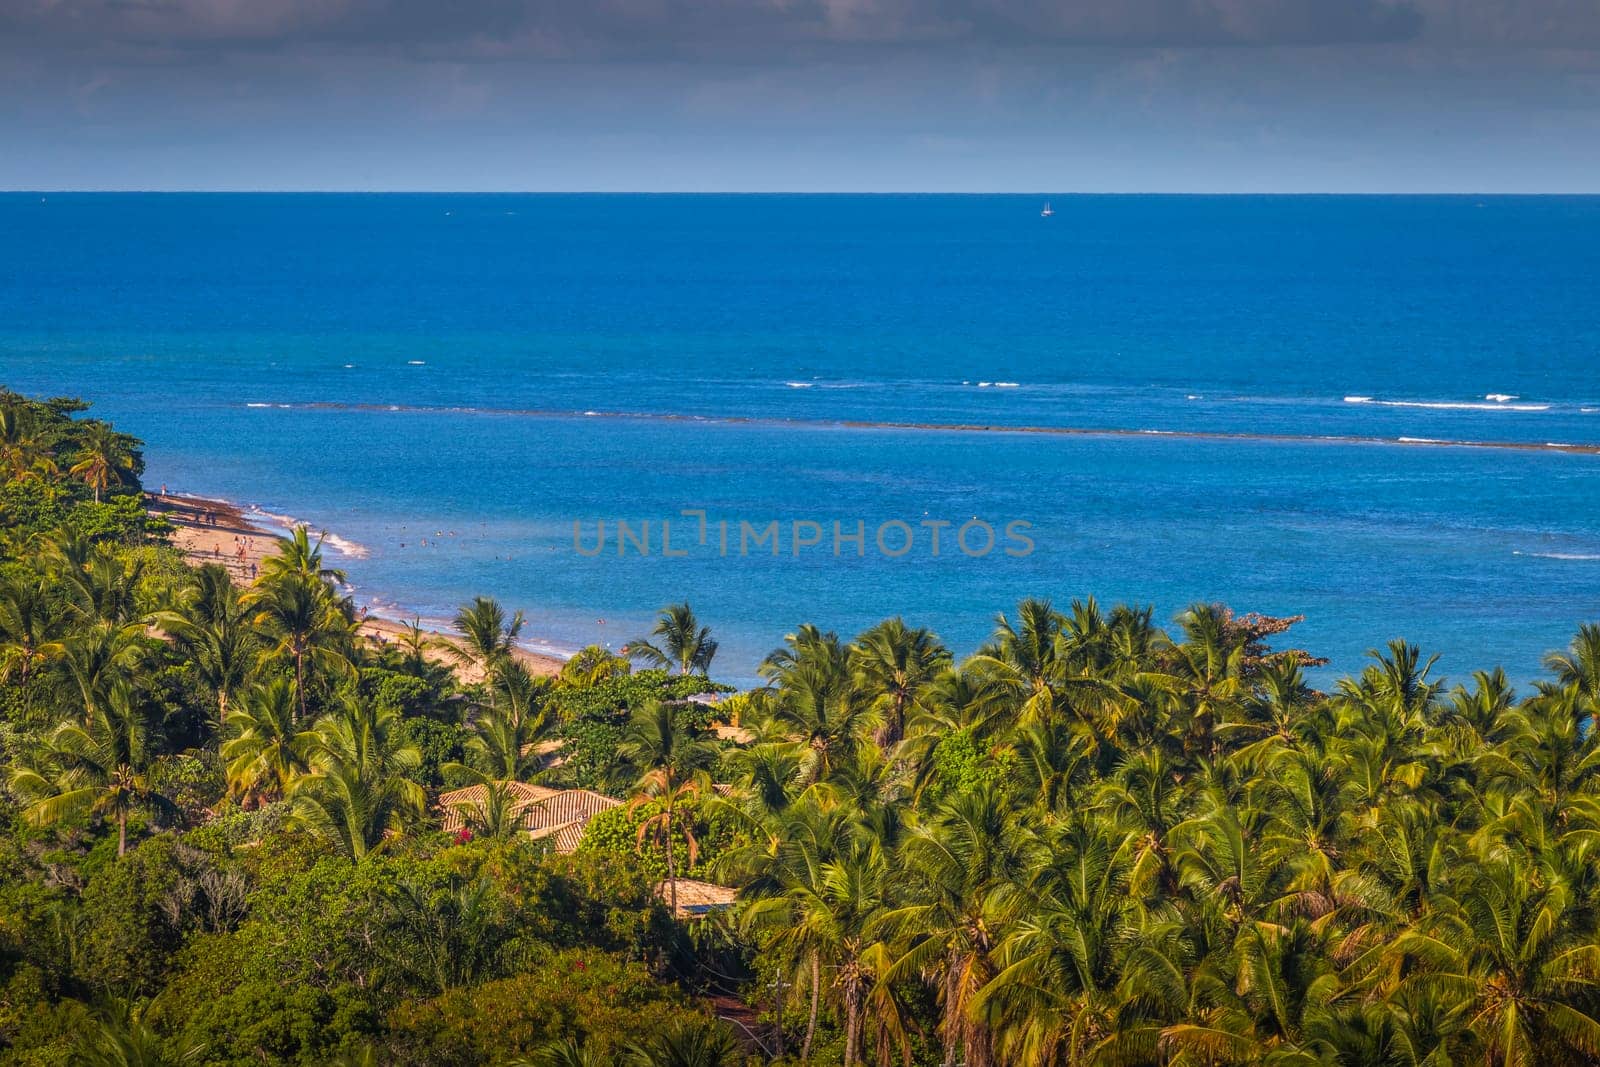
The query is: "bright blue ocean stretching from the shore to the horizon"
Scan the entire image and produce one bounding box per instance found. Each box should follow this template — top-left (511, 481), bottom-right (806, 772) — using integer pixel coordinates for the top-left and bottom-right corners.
top-left (0, 194), bottom-right (1600, 683)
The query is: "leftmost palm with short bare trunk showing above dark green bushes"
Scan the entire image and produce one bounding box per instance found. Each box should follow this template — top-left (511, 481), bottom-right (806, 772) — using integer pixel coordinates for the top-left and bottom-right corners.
top-left (11, 681), bottom-right (174, 856)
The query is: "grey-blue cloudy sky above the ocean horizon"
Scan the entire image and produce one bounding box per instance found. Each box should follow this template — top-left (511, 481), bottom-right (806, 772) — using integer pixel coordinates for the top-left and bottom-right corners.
top-left (0, 0), bottom-right (1600, 195)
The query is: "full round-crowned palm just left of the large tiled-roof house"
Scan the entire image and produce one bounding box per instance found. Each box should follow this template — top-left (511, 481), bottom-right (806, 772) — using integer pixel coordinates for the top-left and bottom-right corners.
top-left (290, 699), bottom-right (426, 862)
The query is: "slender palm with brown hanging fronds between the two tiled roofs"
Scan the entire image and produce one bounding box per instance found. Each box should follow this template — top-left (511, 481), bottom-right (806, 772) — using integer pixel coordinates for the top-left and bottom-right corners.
top-left (618, 702), bottom-right (717, 915)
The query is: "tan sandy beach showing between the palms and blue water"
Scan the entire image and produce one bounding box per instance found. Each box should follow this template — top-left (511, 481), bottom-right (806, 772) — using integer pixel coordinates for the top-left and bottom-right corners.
top-left (146, 493), bottom-right (563, 683)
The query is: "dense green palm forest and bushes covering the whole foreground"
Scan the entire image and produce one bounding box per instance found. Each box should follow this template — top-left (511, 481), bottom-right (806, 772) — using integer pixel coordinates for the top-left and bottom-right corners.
top-left (0, 395), bottom-right (1600, 1067)
